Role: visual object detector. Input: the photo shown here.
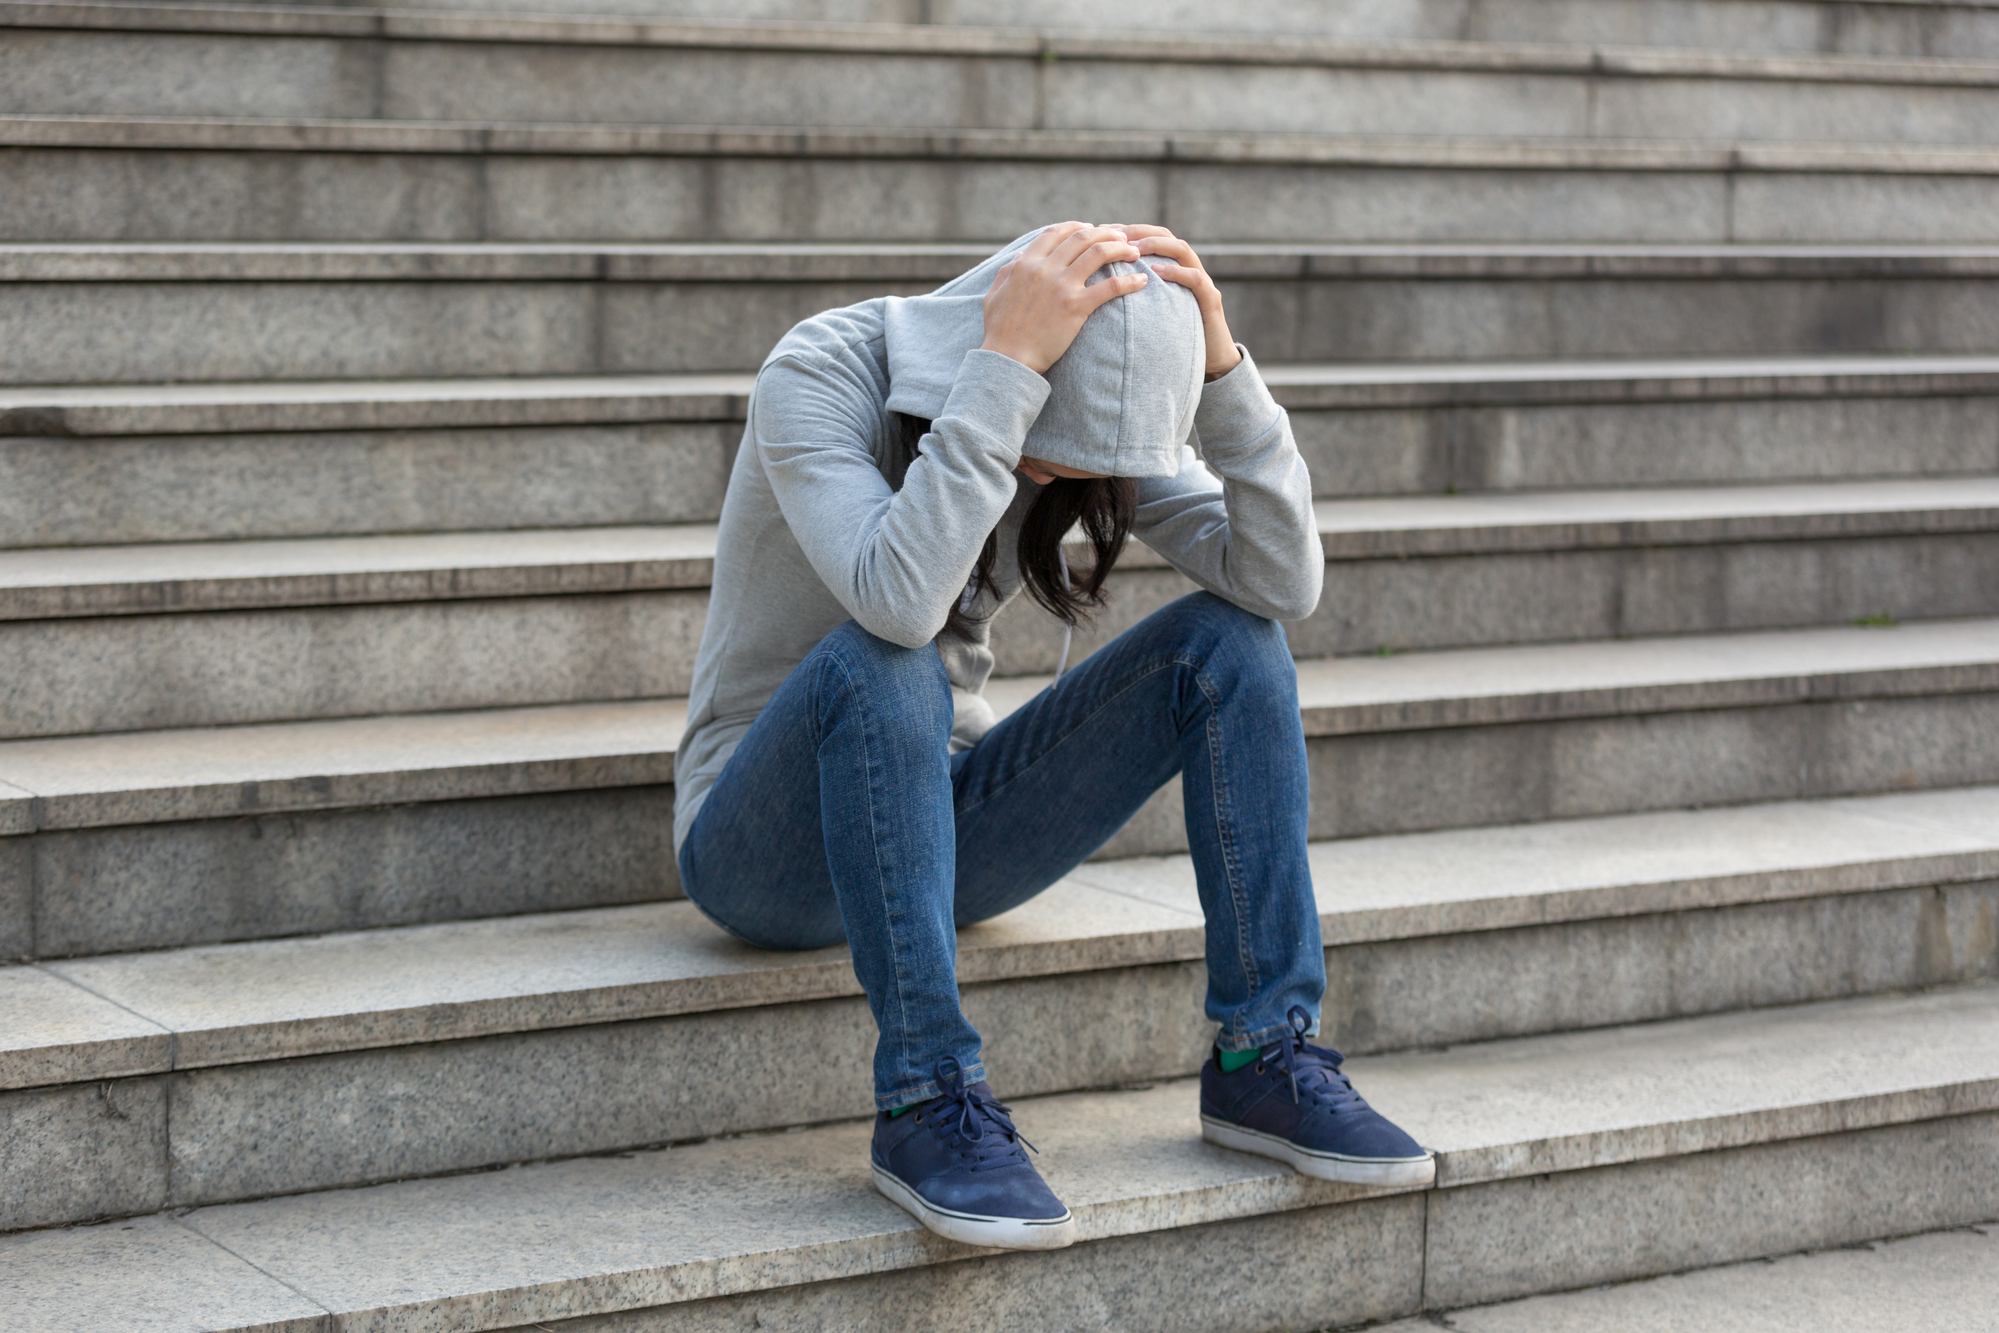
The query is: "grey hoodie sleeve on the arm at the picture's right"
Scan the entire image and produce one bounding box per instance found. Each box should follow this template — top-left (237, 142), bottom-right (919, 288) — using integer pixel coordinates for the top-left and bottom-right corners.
top-left (1131, 346), bottom-right (1325, 620)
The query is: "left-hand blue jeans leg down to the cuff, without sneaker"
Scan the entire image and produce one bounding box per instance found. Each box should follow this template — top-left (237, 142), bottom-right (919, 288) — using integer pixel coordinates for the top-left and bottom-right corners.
top-left (680, 622), bottom-right (986, 1111)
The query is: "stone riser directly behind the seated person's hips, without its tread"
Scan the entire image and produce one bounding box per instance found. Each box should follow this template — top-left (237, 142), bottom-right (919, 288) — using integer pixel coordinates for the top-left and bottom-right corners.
top-left (11, 693), bottom-right (1999, 957)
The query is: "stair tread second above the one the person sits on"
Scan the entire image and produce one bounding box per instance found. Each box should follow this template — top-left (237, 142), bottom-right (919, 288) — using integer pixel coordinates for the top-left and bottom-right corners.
top-left (0, 476), bottom-right (1999, 620)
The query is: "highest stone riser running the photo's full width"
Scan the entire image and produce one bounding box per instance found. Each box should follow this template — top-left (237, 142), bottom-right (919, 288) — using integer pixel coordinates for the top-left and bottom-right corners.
top-left (15, 30), bottom-right (1999, 144)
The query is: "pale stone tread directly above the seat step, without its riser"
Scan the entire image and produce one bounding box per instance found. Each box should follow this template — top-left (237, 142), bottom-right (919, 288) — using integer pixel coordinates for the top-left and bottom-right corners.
top-left (0, 620), bottom-right (1999, 833)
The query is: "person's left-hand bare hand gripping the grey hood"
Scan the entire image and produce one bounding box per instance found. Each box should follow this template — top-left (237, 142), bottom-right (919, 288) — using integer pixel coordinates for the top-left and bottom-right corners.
top-left (980, 222), bottom-right (1147, 376)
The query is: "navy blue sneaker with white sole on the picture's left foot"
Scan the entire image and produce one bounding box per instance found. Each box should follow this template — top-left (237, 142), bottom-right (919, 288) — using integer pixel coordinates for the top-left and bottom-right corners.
top-left (870, 1057), bottom-right (1075, 1249)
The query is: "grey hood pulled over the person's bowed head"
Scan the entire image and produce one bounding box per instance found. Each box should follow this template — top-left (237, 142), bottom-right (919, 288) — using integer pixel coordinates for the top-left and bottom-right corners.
top-left (884, 228), bottom-right (1207, 478)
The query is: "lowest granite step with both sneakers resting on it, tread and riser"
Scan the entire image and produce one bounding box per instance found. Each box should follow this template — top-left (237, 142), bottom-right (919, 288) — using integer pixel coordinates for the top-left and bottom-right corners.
top-left (0, 987), bottom-right (1999, 1333)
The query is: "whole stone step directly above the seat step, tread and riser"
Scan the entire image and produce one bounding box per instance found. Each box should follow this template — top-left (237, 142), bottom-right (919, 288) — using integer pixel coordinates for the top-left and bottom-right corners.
top-left (11, 620), bottom-right (1999, 957)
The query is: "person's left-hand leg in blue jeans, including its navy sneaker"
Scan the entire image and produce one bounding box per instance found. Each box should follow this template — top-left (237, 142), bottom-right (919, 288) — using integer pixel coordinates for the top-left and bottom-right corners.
top-left (680, 622), bottom-right (1075, 1249)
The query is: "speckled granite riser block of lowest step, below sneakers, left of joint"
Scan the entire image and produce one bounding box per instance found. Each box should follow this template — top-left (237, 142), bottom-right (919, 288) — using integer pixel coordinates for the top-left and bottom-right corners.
top-left (547, 1197), bottom-right (1423, 1333)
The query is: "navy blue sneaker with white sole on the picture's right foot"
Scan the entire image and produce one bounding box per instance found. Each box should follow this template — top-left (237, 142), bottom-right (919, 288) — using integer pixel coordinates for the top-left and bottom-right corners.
top-left (1201, 1007), bottom-right (1437, 1185)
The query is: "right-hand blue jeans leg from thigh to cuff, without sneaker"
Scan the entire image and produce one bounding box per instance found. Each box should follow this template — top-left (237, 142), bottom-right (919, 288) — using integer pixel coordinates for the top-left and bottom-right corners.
top-left (954, 592), bottom-right (1325, 1051)
